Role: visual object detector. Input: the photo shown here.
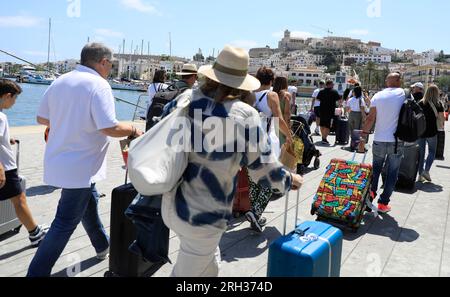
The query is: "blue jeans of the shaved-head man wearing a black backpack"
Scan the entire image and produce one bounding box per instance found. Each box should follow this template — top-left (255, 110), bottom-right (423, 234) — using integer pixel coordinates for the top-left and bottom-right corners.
top-left (372, 142), bottom-right (403, 205)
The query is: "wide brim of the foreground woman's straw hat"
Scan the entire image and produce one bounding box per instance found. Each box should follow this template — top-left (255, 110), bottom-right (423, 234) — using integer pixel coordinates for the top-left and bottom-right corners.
top-left (198, 65), bottom-right (261, 91)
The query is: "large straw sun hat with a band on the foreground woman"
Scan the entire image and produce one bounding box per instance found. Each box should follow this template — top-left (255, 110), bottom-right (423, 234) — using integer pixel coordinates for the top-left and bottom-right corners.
top-left (198, 45), bottom-right (261, 91)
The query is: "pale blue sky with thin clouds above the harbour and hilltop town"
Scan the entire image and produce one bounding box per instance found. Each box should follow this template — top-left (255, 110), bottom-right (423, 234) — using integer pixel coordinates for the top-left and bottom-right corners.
top-left (0, 0), bottom-right (450, 63)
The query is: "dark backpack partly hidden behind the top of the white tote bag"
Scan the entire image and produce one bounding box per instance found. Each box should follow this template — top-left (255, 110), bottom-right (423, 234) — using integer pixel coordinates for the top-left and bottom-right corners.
top-left (145, 84), bottom-right (188, 131)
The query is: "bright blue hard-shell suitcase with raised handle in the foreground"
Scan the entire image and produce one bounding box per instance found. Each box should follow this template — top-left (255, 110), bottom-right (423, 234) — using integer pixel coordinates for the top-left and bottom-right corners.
top-left (267, 191), bottom-right (343, 277)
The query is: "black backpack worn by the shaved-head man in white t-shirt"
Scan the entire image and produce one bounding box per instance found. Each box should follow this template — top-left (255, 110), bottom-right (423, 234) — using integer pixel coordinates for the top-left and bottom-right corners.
top-left (395, 99), bottom-right (427, 142)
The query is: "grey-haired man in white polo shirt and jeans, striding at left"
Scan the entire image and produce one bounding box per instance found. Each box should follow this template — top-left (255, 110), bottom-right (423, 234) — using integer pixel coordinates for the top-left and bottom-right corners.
top-left (28, 43), bottom-right (142, 277)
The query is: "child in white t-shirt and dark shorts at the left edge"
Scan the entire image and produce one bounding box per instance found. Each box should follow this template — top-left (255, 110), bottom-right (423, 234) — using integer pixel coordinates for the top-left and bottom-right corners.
top-left (0, 79), bottom-right (47, 247)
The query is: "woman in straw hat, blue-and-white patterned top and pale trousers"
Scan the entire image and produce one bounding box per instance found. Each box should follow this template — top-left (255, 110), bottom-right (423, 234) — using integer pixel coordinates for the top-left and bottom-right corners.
top-left (162, 46), bottom-right (303, 277)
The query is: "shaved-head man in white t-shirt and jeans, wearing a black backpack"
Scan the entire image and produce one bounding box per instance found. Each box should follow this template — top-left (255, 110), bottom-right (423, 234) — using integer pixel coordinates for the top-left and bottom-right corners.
top-left (359, 73), bottom-right (406, 213)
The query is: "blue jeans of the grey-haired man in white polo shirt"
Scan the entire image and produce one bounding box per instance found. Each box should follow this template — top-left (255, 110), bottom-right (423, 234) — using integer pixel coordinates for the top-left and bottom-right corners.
top-left (27, 185), bottom-right (109, 277)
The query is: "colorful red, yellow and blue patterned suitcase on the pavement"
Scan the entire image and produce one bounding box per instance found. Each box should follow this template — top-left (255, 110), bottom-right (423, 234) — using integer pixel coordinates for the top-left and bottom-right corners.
top-left (311, 153), bottom-right (377, 232)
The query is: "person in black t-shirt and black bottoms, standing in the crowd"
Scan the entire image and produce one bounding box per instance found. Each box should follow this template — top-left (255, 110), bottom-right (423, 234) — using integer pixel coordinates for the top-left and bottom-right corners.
top-left (317, 80), bottom-right (341, 144)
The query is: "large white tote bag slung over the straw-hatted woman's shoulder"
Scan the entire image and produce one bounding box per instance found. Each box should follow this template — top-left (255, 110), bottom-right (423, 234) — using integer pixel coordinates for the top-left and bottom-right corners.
top-left (128, 91), bottom-right (192, 196)
